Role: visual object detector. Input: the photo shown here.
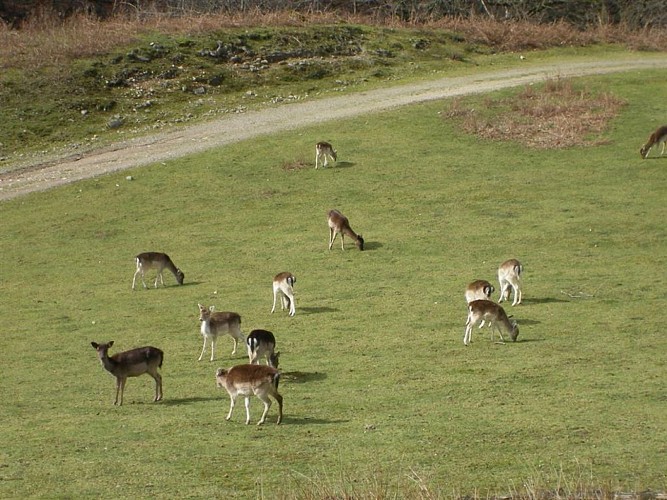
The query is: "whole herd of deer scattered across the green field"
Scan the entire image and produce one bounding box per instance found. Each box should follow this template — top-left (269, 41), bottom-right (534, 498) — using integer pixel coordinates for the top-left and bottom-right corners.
top-left (91, 125), bottom-right (667, 425)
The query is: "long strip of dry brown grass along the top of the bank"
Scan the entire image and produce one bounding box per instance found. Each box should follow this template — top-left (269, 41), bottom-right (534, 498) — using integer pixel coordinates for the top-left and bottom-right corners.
top-left (0, 11), bottom-right (667, 69)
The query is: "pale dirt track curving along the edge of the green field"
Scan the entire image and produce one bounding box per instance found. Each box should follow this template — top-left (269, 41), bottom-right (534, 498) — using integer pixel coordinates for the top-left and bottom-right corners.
top-left (0, 54), bottom-right (667, 200)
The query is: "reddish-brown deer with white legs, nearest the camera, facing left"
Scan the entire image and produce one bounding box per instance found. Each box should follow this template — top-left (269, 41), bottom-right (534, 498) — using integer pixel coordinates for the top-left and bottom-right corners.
top-left (215, 365), bottom-right (283, 425)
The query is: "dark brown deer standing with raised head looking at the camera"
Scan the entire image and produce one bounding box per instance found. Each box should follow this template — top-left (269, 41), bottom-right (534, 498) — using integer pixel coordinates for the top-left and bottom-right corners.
top-left (90, 340), bottom-right (164, 406)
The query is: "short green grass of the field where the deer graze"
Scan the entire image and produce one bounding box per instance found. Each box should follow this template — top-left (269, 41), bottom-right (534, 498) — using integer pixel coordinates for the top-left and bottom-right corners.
top-left (0, 71), bottom-right (667, 498)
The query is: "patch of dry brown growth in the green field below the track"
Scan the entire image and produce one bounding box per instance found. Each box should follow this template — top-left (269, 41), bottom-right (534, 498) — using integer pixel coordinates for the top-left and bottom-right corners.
top-left (443, 79), bottom-right (625, 149)
